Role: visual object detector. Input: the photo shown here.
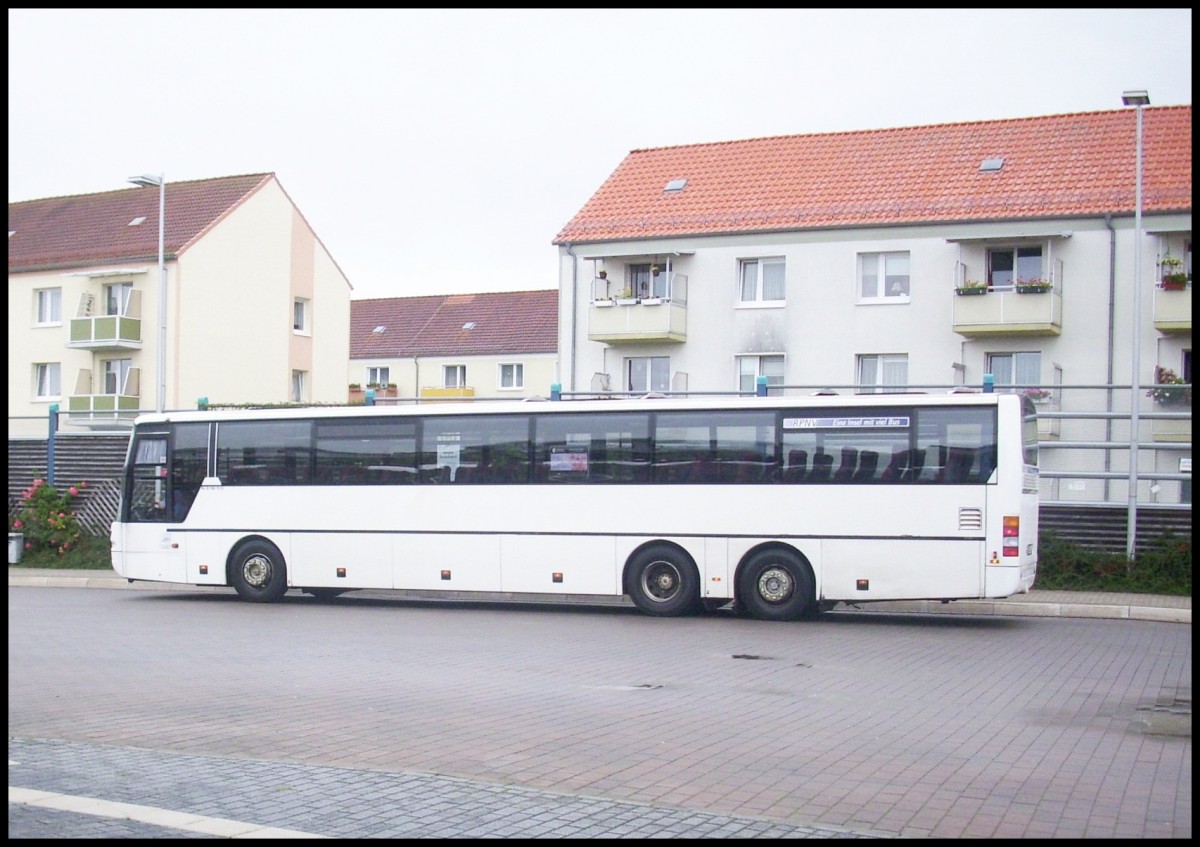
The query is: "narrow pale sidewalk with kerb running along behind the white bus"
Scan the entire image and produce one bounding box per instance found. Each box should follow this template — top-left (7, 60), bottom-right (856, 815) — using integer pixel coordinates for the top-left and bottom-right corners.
top-left (8, 565), bottom-right (1192, 624)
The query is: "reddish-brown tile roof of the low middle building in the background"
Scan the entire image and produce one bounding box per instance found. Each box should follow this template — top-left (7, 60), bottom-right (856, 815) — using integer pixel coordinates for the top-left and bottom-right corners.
top-left (350, 290), bottom-right (558, 359)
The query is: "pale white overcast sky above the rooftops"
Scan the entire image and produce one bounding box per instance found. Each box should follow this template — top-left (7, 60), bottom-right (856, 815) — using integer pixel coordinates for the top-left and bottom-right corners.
top-left (8, 8), bottom-right (1192, 298)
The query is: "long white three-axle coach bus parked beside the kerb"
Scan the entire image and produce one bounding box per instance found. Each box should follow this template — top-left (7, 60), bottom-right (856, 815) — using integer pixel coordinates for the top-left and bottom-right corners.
top-left (112, 392), bottom-right (1038, 620)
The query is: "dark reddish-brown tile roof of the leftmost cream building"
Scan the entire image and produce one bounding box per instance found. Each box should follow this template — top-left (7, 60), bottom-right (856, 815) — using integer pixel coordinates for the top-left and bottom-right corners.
top-left (8, 174), bottom-right (275, 274)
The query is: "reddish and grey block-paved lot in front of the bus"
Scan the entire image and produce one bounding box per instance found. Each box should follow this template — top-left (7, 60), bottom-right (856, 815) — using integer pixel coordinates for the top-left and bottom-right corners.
top-left (8, 588), bottom-right (1192, 837)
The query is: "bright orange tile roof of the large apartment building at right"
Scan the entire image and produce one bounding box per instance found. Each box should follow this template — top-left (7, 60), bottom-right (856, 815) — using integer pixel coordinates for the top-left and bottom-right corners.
top-left (553, 106), bottom-right (1192, 244)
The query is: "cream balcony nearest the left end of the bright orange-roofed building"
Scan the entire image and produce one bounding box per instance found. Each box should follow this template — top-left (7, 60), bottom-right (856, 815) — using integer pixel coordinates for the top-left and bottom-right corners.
top-left (588, 274), bottom-right (688, 343)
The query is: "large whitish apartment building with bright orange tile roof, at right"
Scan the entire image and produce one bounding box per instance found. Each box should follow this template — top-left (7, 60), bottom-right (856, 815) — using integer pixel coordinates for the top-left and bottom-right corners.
top-left (553, 106), bottom-right (1192, 503)
